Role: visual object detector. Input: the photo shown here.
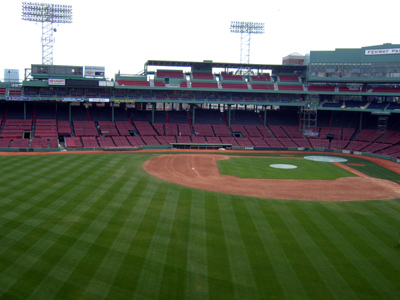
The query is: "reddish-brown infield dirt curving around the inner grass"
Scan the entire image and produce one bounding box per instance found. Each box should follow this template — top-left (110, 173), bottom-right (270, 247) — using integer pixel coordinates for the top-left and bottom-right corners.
top-left (143, 154), bottom-right (400, 201)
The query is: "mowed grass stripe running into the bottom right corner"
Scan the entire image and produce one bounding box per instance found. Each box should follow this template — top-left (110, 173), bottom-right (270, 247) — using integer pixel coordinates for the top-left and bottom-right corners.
top-left (315, 204), bottom-right (400, 299)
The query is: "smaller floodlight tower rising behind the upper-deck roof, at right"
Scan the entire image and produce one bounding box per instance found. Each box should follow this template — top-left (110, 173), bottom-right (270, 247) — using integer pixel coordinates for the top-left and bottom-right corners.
top-left (231, 21), bottom-right (264, 75)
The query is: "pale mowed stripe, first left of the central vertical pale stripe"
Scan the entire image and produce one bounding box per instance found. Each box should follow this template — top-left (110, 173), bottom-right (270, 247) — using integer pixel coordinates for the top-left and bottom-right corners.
top-left (133, 184), bottom-right (179, 299)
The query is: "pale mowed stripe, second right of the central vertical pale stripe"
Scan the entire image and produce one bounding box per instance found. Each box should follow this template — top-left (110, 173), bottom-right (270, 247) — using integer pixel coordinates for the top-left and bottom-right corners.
top-left (245, 201), bottom-right (308, 299)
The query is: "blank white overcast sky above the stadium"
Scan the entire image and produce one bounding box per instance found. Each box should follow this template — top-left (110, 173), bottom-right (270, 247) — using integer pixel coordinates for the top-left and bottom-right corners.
top-left (0, 0), bottom-right (400, 79)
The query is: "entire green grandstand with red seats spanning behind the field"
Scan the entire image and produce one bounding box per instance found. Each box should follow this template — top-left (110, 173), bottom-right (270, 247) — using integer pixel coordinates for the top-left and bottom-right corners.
top-left (0, 44), bottom-right (400, 158)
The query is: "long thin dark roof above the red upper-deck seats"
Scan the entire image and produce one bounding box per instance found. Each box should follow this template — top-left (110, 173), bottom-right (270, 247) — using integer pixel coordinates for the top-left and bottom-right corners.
top-left (144, 60), bottom-right (307, 73)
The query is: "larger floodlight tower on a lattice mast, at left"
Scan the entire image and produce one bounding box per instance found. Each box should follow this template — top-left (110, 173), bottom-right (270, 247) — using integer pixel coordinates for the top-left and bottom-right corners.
top-left (22, 2), bottom-right (72, 65)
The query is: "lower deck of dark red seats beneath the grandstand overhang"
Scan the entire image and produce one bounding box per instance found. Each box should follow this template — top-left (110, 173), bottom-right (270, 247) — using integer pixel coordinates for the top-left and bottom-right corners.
top-left (0, 101), bottom-right (400, 158)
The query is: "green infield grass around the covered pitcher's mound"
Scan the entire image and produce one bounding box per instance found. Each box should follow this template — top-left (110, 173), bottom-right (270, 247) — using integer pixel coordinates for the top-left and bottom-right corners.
top-left (217, 157), bottom-right (356, 180)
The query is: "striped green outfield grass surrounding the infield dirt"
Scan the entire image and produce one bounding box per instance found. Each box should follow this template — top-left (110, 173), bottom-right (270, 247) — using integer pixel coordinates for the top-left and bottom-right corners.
top-left (0, 153), bottom-right (400, 300)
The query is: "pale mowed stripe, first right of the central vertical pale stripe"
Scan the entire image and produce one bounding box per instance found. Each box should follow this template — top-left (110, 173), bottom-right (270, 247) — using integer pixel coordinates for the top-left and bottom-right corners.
top-left (218, 196), bottom-right (260, 299)
